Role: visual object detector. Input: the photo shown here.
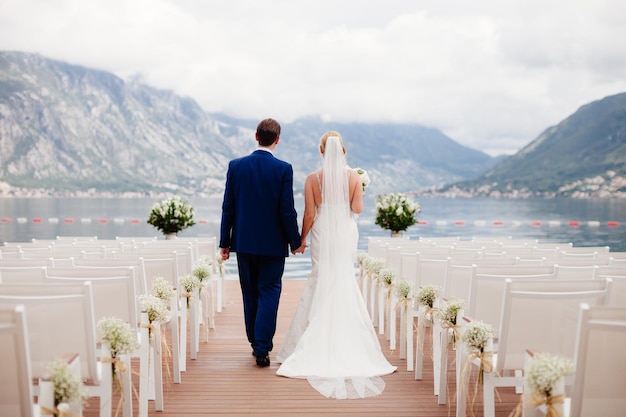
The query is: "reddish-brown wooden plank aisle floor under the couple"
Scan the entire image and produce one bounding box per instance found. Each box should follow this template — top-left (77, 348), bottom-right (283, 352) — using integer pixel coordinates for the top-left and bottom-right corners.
top-left (84, 280), bottom-right (519, 417)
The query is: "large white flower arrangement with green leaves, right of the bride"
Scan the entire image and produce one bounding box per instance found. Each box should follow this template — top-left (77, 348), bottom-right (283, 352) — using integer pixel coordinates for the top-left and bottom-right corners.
top-left (374, 193), bottom-right (421, 233)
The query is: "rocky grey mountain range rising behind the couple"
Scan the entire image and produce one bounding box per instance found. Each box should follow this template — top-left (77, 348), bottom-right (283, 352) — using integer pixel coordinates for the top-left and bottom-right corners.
top-left (0, 52), bottom-right (494, 195)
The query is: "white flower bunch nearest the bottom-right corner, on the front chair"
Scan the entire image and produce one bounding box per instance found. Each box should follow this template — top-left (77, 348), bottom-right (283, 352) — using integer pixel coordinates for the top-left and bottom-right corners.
top-left (524, 353), bottom-right (574, 397)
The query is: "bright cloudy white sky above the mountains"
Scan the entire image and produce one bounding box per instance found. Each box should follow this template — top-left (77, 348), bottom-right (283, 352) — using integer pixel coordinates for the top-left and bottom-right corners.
top-left (0, 0), bottom-right (626, 155)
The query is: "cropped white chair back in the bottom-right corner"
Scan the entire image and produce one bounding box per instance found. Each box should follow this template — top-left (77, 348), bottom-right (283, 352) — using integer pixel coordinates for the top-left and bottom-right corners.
top-left (569, 304), bottom-right (626, 417)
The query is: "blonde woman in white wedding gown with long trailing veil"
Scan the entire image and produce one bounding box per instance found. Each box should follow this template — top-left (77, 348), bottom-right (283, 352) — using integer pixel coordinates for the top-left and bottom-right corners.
top-left (276, 131), bottom-right (396, 399)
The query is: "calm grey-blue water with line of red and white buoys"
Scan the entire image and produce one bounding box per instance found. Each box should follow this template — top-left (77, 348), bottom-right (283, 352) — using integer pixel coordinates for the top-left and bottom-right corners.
top-left (0, 197), bottom-right (626, 277)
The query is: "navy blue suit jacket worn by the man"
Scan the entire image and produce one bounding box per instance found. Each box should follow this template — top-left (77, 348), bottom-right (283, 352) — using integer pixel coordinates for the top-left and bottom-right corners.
top-left (219, 149), bottom-right (300, 257)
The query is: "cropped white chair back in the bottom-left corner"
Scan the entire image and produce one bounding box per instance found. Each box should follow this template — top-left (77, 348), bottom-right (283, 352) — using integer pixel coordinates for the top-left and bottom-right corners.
top-left (0, 305), bottom-right (39, 417)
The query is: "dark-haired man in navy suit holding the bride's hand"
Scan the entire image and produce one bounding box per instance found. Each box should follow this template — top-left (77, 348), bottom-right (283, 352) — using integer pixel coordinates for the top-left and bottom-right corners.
top-left (220, 115), bottom-right (301, 367)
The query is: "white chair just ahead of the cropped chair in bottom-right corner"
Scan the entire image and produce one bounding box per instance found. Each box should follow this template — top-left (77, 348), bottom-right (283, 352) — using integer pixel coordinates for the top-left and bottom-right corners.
top-left (470, 279), bottom-right (611, 417)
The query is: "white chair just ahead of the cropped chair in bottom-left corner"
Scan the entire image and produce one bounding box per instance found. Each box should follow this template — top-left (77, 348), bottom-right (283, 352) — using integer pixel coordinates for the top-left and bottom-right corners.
top-left (0, 282), bottom-right (112, 417)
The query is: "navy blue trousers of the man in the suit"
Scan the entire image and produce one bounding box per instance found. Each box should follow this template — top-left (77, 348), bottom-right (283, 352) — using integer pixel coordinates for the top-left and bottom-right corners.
top-left (237, 252), bottom-right (285, 357)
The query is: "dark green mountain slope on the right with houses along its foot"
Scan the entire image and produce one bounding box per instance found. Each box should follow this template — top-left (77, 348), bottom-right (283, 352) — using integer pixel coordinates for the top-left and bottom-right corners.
top-left (422, 93), bottom-right (626, 198)
